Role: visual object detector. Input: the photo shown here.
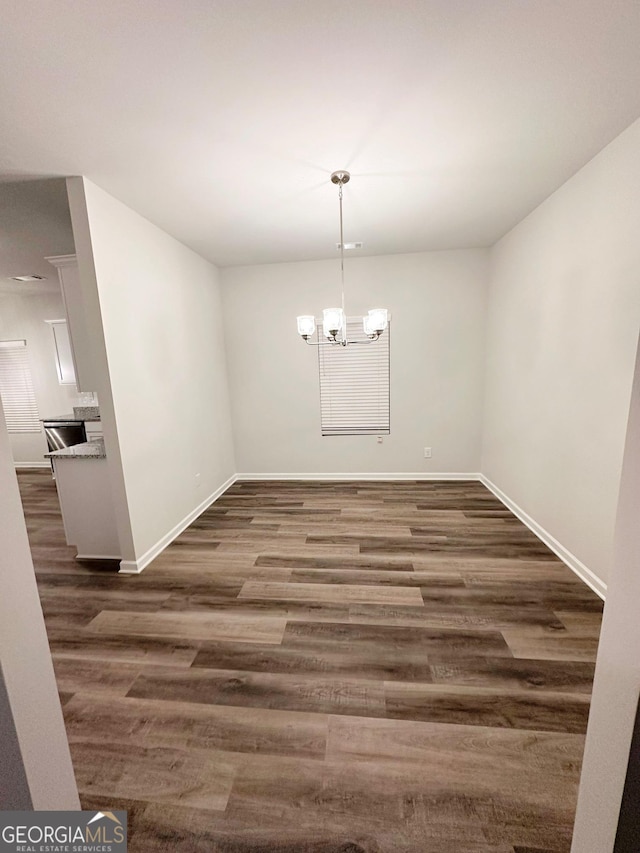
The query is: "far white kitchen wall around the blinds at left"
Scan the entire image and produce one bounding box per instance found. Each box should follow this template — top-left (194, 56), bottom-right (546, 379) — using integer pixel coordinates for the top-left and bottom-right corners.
top-left (0, 292), bottom-right (77, 465)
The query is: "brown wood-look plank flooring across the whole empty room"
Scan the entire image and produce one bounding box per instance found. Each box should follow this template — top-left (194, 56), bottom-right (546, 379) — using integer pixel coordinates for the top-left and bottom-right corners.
top-left (19, 471), bottom-right (602, 853)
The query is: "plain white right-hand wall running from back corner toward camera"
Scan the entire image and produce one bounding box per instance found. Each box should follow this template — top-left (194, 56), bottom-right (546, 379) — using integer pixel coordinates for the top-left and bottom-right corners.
top-left (482, 116), bottom-right (640, 584)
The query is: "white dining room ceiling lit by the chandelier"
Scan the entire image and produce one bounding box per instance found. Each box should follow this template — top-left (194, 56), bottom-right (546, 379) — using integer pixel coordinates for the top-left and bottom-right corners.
top-left (0, 0), bottom-right (640, 266)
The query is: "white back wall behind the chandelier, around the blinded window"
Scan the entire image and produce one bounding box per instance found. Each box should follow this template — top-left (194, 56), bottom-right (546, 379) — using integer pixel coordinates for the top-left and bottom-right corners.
top-left (222, 249), bottom-right (488, 474)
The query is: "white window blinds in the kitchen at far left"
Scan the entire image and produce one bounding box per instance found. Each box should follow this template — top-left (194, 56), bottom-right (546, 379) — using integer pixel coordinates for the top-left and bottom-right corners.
top-left (0, 341), bottom-right (42, 432)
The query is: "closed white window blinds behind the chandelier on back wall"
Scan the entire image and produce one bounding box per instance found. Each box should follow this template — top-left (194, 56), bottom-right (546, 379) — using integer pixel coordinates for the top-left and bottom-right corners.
top-left (318, 318), bottom-right (391, 435)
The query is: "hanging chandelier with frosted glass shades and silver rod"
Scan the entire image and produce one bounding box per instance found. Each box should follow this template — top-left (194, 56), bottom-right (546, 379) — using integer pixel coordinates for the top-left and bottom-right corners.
top-left (297, 170), bottom-right (388, 347)
